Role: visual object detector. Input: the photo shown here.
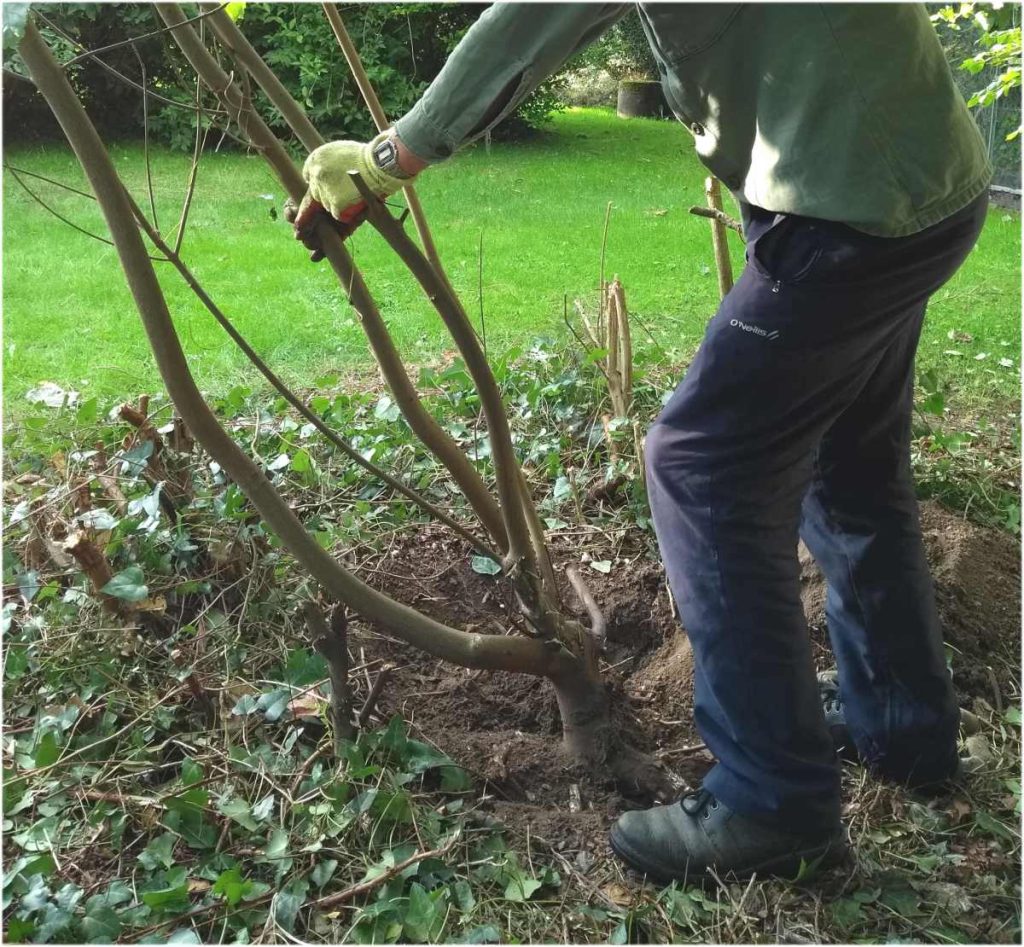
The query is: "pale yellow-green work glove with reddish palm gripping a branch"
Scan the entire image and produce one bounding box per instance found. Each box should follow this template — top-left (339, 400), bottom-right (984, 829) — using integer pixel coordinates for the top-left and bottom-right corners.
top-left (285, 131), bottom-right (413, 263)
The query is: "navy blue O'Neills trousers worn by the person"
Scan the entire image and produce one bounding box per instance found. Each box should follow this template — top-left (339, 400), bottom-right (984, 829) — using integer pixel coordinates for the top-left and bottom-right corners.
top-left (646, 198), bottom-right (987, 827)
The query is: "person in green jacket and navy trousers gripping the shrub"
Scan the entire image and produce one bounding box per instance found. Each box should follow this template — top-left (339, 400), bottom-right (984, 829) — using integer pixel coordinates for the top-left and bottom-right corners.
top-left (295, 3), bottom-right (991, 879)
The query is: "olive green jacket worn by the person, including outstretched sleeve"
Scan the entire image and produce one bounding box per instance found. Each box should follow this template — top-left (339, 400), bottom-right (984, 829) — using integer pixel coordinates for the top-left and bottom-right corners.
top-left (395, 3), bottom-right (991, 236)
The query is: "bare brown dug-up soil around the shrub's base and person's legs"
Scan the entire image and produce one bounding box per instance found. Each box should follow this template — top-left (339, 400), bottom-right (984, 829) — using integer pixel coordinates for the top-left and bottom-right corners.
top-left (350, 504), bottom-right (1021, 863)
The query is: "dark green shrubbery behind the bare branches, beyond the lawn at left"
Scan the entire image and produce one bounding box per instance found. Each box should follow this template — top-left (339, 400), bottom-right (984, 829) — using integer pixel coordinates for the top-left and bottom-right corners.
top-left (5, 3), bottom-right (560, 152)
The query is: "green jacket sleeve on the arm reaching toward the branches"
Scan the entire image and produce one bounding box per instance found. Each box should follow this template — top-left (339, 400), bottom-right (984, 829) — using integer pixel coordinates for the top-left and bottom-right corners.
top-left (395, 2), bottom-right (631, 163)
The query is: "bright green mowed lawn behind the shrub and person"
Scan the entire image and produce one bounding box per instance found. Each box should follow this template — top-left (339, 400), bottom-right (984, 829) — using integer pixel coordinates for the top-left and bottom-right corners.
top-left (3, 110), bottom-right (1020, 419)
